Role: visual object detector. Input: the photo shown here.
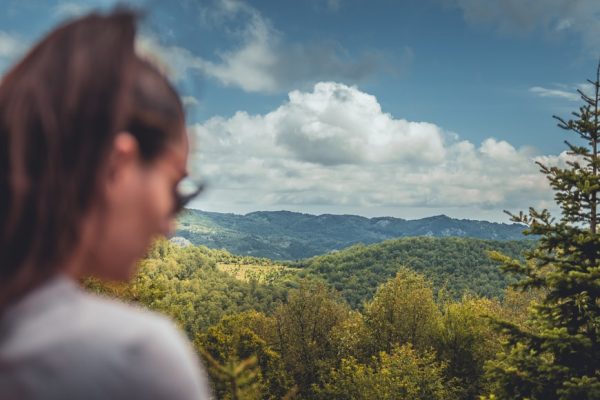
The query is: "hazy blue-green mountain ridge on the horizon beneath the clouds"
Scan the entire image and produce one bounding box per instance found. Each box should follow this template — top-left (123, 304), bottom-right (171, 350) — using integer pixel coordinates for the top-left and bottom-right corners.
top-left (176, 209), bottom-right (524, 260)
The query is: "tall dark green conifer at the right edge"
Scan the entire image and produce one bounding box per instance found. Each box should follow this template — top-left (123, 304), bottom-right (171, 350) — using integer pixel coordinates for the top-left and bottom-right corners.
top-left (487, 63), bottom-right (600, 399)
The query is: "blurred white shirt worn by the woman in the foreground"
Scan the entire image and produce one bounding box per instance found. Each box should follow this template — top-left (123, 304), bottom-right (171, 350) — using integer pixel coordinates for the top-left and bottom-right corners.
top-left (0, 276), bottom-right (211, 400)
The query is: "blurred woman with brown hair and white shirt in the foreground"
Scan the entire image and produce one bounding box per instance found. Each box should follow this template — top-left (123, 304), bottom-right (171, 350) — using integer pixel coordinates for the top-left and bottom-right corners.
top-left (0, 11), bottom-right (209, 399)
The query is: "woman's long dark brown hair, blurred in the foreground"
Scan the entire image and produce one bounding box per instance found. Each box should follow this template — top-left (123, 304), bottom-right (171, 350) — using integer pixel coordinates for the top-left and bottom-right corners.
top-left (0, 10), bottom-right (184, 309)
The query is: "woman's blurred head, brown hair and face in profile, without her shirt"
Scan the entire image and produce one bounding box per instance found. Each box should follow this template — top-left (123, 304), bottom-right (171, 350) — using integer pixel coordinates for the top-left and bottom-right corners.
top-left (0, 11), bottom-right (187, 304)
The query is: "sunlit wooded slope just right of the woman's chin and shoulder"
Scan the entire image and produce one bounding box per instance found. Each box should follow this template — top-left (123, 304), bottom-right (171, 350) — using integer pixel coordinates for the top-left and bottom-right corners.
top-left (85, 240), bottom-right (297, 339)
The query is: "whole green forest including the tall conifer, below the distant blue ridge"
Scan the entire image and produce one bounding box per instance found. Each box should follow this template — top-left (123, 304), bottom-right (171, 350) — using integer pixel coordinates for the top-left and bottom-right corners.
top-left (85, 65), bottom-right (600, 400)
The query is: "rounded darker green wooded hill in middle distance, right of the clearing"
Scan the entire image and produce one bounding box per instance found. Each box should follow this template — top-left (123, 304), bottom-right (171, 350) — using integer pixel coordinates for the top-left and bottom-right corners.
top-left (296, 237), bottom-right (535, 307)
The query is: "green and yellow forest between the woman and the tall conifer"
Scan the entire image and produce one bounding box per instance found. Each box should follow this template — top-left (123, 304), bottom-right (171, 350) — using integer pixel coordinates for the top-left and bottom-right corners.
top-left (86, 238), bottom-right (539, 399)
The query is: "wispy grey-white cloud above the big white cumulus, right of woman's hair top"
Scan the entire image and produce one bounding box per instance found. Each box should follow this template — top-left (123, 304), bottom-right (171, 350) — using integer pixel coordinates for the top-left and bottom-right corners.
top-left (139, 0), bottom-right (398, 93)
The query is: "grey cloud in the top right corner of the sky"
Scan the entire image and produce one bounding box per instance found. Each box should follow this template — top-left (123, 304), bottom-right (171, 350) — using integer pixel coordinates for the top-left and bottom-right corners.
top-left (444, 0), bottom-right (600, 57)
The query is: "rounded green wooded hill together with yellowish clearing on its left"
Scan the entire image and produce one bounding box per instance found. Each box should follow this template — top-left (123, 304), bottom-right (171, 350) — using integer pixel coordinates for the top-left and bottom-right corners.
top-left (164, 237), bottom-right (535, 308)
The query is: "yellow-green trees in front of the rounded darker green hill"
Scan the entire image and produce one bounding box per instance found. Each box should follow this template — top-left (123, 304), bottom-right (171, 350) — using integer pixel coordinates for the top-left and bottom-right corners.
top-left (87, 241), bottom-right (535, 399)
